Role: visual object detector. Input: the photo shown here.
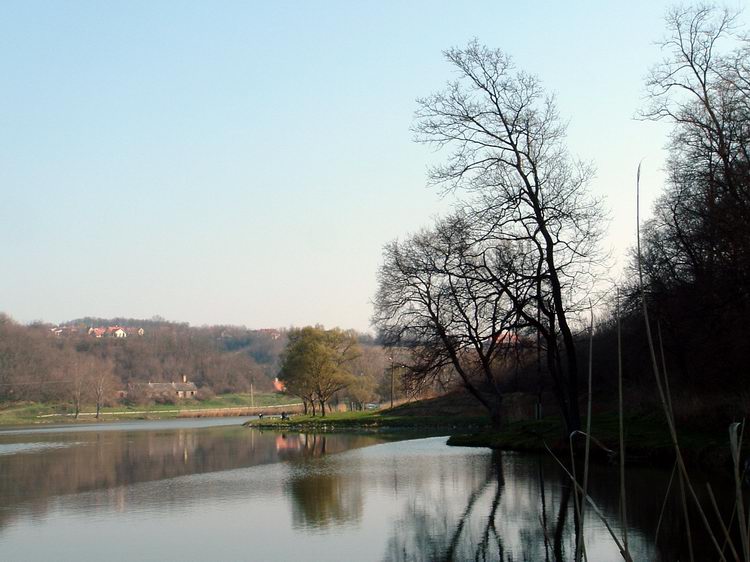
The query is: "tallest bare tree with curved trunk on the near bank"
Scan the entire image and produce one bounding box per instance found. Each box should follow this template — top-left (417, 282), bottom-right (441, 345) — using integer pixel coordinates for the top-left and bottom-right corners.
top-left (406, 42), bottom-right (603, 430)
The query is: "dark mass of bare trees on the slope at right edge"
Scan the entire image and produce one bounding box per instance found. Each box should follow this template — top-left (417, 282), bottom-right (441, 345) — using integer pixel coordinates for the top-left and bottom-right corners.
top-left (594, 6), bottom-right (750, 424)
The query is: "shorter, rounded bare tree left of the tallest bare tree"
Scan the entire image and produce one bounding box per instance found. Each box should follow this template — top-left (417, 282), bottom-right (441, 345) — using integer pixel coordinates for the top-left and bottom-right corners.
top-left (374, 214), bottom-right (536, 426)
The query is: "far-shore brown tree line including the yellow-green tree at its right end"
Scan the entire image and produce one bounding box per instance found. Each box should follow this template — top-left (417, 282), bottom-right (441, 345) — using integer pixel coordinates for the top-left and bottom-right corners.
top-left (0, 314), bottom-right (403, 413)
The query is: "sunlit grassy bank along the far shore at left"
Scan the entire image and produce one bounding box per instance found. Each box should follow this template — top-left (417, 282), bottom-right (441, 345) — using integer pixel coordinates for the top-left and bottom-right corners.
top-left (0, 393), bottom-right (297, 426)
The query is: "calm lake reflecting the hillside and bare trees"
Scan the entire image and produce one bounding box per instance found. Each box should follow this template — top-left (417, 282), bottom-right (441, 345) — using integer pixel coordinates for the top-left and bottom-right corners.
top-left (0, 418), bottom-right (732, 561)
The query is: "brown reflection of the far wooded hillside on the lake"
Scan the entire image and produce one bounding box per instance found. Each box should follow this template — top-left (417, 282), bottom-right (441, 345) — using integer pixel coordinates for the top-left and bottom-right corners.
top-left (0, 420), bottom-right (383, 531)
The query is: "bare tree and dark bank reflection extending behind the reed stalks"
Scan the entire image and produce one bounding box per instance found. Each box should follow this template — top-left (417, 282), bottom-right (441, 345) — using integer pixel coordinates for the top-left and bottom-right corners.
top-left (383, 442), bottom-right (726, 562)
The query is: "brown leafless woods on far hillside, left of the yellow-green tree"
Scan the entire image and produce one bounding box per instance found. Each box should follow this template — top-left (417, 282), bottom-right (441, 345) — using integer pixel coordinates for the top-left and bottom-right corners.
top-left (0, 315), bottom-right (285, 402)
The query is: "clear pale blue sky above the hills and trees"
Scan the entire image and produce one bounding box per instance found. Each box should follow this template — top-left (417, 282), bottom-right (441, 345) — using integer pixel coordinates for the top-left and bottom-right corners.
top-left (0, 0), bottom-right (748, 331)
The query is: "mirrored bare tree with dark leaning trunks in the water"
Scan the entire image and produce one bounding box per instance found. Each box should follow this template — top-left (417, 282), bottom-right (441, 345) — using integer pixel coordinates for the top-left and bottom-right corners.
top-left (384, 451), bottom-right (666, 562)
